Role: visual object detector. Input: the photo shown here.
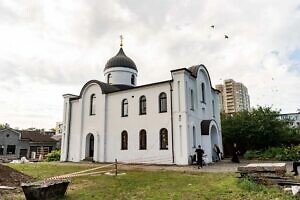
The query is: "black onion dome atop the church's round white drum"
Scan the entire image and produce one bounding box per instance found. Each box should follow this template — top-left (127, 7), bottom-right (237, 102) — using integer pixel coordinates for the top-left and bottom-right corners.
top-left (104, 47), bottom-right (137, 71)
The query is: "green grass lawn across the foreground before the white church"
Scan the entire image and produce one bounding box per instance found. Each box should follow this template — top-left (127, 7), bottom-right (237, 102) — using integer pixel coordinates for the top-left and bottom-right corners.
top-left (5, 163), bottom-right (296, 200)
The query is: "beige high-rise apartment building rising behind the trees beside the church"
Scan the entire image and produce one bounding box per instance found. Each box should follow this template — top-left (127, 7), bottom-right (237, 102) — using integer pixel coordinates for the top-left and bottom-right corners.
top-left (216, 79), bottom-right (250, 113)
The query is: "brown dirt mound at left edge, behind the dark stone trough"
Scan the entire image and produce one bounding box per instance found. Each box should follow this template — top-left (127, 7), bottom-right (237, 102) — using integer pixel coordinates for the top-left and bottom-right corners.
top-left (0, 164), bottom-right (34, 187)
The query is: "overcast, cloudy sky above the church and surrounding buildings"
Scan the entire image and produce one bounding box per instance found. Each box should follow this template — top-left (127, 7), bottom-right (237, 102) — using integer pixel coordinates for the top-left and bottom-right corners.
top-left (0, 0), bottom-right (300, 129)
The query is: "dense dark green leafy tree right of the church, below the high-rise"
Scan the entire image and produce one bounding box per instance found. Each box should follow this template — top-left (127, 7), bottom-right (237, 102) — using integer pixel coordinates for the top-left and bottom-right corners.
top-left (221, 107), bottom-right (291, 152)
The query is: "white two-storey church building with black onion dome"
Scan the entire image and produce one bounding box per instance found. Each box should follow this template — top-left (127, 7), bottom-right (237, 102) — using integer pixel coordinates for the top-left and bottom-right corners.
top-left (61, 45), bottom-right (223, 165)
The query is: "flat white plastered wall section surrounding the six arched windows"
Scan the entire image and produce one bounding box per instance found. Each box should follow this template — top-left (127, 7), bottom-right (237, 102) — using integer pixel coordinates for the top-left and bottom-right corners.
top-left (106, 82), bottom-right (172, 164)
